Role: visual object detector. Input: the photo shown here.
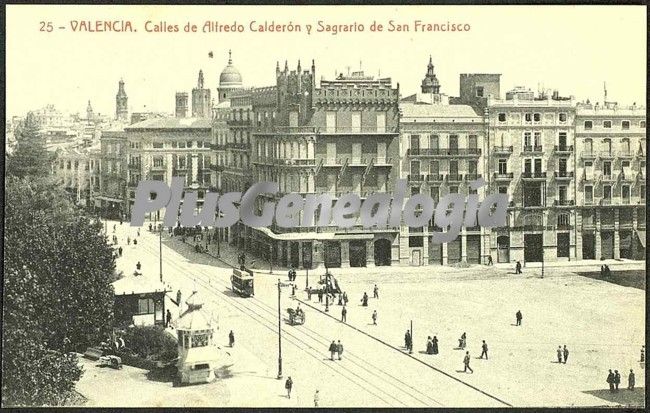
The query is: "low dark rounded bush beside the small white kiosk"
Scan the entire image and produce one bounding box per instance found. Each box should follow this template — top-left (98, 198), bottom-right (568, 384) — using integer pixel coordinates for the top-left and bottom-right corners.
top-left (123, 326), bottom-right (178, 361)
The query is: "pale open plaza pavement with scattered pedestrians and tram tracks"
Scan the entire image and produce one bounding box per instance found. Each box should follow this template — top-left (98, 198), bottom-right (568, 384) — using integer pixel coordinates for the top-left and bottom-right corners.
top-left (82, 220), bottom-right (645, 406)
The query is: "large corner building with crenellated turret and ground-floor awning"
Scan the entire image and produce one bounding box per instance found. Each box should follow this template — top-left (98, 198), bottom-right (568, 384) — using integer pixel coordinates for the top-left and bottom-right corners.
top-left (251, 62), bottom-right (399, 268)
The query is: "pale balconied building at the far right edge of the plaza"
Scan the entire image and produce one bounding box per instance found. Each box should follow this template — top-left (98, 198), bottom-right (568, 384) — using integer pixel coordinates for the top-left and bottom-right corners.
top-left (575, 102), bottom-right (647, 259)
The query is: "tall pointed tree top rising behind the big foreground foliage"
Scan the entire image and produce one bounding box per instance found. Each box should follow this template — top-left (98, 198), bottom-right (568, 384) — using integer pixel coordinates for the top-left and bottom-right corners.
top-left (6, 112), bottom-right (52, 178)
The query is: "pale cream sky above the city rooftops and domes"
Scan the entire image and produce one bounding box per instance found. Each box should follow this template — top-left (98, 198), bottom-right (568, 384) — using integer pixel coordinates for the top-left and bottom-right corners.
top-left (6, 5), bottom-right (647, 116)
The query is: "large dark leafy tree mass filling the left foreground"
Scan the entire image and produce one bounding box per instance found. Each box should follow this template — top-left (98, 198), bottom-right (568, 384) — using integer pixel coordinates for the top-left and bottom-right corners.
top-left (2, 176), bottom-right (115, 405)
